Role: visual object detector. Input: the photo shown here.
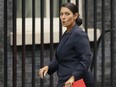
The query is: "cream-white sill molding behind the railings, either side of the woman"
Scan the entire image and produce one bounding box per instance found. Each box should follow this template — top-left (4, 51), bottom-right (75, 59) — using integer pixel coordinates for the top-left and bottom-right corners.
top-left (10, 18), bottom-right (100, 46)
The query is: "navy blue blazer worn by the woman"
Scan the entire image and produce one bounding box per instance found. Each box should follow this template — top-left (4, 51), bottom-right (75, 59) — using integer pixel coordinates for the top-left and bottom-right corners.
top-left (48, 25), bottom-right (91, 80)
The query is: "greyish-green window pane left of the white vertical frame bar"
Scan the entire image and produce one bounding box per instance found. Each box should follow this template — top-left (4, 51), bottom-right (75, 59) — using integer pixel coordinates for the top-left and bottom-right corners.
top-left (17, 0), bottom-right (46, 18)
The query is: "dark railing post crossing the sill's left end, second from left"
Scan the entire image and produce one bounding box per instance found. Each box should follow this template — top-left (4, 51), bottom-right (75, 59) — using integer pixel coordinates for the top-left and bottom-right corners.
top-left (13, 0), bottom-right (17, 87)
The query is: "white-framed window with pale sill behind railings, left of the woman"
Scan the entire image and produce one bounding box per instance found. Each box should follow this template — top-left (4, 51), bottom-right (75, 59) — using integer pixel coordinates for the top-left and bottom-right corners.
top-left (10, 0), bottom-right (85, 45)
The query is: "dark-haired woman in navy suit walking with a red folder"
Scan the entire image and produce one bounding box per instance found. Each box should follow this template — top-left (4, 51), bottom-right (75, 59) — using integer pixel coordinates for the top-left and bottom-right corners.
top-left (39, 3), bottom-right (93, 87)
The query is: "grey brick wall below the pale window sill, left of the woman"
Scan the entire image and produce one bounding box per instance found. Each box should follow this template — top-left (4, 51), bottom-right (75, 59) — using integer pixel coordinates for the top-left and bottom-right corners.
top-left (8, 45), bottom-right (57, 87)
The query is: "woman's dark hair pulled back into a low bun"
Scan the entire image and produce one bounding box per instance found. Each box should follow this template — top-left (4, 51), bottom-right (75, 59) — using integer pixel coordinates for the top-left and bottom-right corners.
top-left (61, 3), bottom-right (82, 26)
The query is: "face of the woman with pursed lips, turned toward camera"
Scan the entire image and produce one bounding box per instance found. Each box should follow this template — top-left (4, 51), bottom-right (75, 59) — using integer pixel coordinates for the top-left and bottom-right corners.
top-left (60, 7), bottom-right (78, 29)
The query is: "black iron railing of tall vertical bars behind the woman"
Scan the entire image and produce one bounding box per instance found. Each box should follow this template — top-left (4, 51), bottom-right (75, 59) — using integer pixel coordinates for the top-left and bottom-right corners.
top-left (4, 0), bottom-right (115, 87)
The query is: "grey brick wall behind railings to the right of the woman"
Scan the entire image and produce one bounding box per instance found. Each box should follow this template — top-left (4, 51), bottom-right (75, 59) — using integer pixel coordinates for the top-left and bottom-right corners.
top-left (88, 0), bottom-right (116, 87)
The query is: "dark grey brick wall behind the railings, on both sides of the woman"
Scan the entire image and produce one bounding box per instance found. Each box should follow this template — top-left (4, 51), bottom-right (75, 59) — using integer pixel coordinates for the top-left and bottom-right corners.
top-left (0, 0), bottom-right (116, 87)
